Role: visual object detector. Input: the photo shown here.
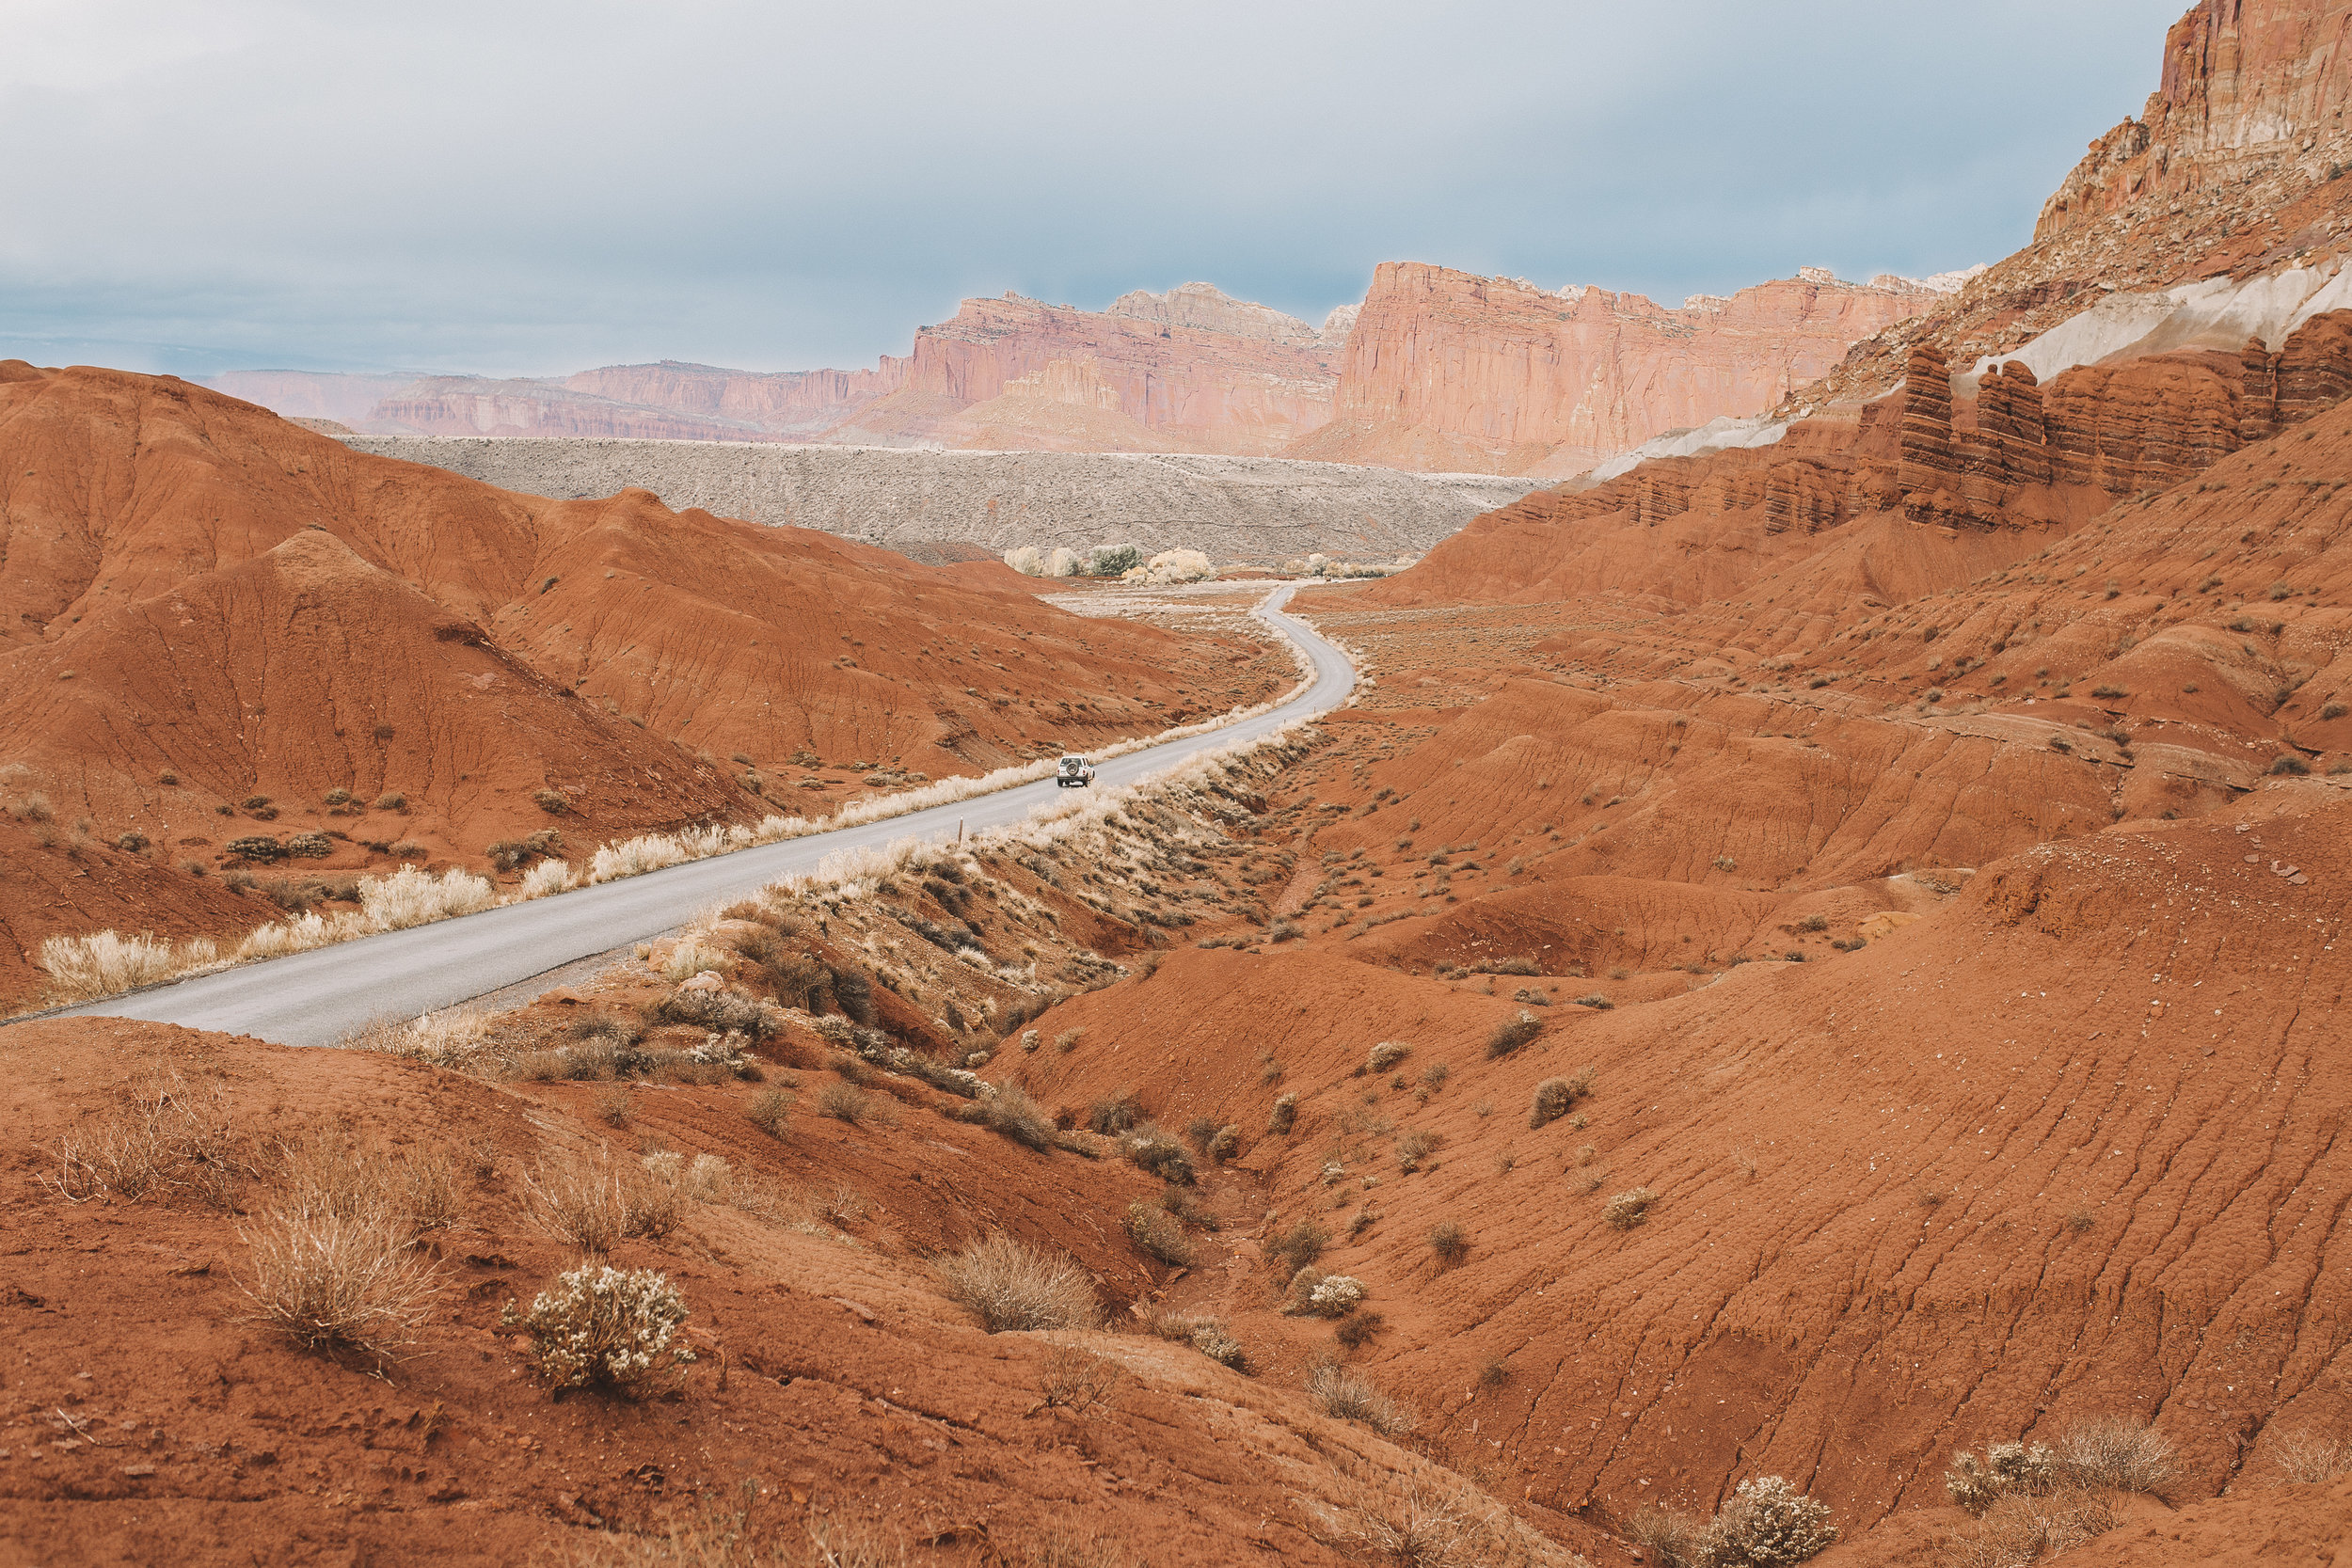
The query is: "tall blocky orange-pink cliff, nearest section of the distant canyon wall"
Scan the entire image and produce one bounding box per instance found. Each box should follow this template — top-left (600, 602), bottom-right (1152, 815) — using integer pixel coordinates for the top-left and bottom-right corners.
top-left (1292, 261), bottom-right (1941, 477)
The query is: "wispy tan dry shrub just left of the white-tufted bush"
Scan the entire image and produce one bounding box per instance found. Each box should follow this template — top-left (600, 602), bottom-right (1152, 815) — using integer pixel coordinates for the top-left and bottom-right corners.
top-left (240, 1199), bottom-right (442, 1356)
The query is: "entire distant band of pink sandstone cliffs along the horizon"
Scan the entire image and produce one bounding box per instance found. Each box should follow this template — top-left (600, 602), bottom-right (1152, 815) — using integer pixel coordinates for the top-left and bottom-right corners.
top-left (219, 263), bottom-right (1941, 477)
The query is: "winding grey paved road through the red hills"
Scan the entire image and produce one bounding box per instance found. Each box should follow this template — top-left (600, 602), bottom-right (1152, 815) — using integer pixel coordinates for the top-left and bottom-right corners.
top-left (37, 588), bottom-right (1355, 1046)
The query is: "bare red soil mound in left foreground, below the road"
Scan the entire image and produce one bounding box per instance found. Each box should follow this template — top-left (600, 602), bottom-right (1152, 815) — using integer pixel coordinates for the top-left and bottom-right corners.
top-left (0, 1021), bottom-right (1574, 1563)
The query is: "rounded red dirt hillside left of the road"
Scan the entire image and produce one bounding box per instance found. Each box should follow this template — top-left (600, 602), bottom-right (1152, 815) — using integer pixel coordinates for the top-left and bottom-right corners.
top-left (0, 362), bottom-right (1294, 992)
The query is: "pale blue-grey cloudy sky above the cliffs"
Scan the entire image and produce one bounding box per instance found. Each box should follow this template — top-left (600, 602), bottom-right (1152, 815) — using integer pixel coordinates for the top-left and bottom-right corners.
top-left (0, 0), bottom-right (2187, 376)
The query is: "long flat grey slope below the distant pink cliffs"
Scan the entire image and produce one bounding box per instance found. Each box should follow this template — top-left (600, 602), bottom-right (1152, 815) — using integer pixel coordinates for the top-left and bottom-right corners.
top-left (342, 435), bottom-right (1536, 562)
